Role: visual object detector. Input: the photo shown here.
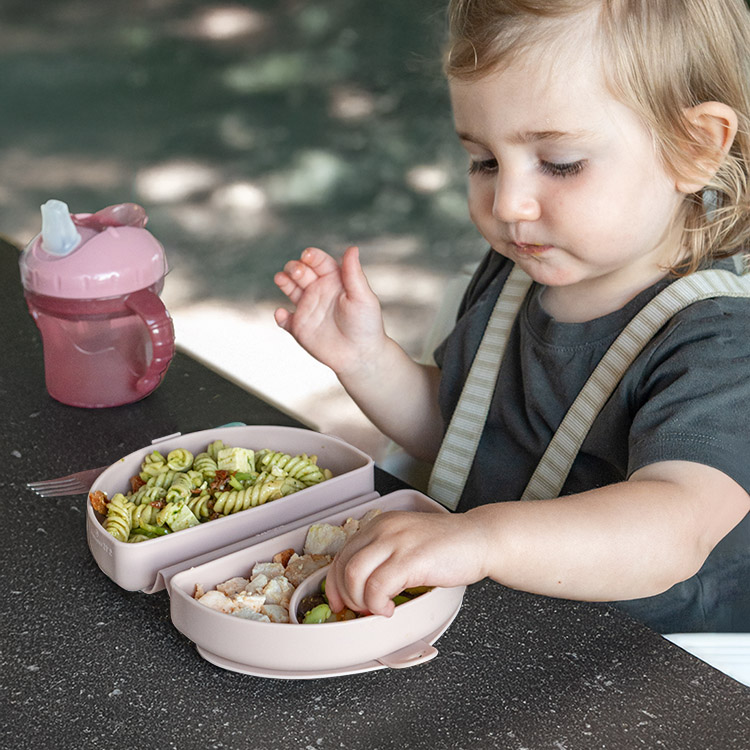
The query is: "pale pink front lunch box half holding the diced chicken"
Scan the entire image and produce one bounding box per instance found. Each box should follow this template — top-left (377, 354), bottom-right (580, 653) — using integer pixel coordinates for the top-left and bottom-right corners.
top-left (168, 490), bottom-right (466, 679)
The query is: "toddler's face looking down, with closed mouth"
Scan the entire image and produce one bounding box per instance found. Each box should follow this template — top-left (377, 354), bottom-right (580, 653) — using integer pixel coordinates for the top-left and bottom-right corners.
top-left (450, 44), bottom-right (684, 300)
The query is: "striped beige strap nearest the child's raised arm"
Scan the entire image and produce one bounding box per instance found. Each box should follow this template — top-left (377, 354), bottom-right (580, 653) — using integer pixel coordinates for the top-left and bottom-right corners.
top-left (427, 265), bottom-right (531, 510)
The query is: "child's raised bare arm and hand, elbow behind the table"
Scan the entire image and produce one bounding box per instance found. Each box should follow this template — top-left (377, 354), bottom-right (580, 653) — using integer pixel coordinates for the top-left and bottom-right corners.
top-left (274, 247), bottom-right (443, 460)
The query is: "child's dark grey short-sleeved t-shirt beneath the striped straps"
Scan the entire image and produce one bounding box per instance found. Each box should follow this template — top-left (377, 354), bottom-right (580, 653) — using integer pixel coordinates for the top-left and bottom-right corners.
top-left (435, 251), bottom-right (750, 632)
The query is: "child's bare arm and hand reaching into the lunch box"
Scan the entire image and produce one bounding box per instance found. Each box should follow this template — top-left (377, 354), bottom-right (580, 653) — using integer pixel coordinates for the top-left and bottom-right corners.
top-left (326, 461), bottom-right (750, 615)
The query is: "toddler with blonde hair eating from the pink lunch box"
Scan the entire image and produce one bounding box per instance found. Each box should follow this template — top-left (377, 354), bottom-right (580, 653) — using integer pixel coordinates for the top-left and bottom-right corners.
top-left (275, 0), bottom-right (750, 632)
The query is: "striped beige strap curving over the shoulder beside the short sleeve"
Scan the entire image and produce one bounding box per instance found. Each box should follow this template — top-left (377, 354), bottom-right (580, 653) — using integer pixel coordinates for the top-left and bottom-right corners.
top-left (521, 270), bottom-right (750, 500)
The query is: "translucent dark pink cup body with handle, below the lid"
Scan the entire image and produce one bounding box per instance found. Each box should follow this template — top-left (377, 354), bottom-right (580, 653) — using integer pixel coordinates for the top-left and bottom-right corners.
top-left (26, 282), bottom-right (174, 408)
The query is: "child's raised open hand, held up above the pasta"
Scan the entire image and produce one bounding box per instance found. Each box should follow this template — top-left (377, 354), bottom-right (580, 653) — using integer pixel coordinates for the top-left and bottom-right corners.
top-left (274, 247), bottom-right (386, 375)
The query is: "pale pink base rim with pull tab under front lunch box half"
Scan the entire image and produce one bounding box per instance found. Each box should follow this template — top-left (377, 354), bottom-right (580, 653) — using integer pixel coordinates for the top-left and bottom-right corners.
top-left (196, 604), bottom-right (461, 680)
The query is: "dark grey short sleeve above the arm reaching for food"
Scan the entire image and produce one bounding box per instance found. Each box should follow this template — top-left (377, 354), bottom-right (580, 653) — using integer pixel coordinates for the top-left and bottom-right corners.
top-left (626, 297), bottom-right (750, 491)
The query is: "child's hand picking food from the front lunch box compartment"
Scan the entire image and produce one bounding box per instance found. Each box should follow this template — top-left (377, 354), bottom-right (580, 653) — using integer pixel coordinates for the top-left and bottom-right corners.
top-left (326, 511), bottom-right (486, 617)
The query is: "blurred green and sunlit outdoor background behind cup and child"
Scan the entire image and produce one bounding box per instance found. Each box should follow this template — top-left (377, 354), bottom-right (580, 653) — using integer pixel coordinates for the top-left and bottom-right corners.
top-left (0, 0), bottom-right (483, 458)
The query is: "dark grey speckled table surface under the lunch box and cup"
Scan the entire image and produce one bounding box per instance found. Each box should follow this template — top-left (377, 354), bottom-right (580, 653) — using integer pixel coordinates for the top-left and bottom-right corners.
top-left (0, 243), bottom-right (750, 750)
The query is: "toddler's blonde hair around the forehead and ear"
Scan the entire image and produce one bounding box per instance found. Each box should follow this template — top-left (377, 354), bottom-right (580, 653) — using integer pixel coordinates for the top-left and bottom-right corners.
top-left (444, 0), bottom-right (750, 274)
